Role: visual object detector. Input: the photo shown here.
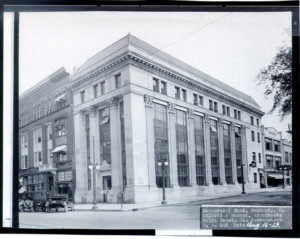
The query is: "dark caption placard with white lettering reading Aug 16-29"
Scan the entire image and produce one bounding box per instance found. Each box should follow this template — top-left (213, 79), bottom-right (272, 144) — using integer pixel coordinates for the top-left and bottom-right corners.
top-left (200, 205), bottom-right (292, 230)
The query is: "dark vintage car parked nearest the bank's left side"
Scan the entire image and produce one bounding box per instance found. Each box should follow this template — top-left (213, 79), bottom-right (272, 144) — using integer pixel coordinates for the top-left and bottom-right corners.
top-left (46, 194), bottom-right (74, 212)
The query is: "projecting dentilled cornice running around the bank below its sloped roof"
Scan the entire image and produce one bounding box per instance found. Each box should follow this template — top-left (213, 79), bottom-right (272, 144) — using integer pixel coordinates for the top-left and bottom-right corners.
top-left (68, 51), bottom-right (264, 116)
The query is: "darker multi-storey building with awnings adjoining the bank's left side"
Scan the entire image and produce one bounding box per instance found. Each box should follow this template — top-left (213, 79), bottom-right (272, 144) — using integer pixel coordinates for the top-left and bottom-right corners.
top-left (19, 68), bottom-right (75, 201)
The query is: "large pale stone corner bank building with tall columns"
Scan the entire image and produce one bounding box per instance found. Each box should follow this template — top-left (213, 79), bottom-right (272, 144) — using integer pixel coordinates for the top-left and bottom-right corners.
top-left (69, 34), bottom-right (264, 203)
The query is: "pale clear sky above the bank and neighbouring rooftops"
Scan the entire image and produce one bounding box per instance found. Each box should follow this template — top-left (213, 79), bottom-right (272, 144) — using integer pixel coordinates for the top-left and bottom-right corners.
top-left (15, 12), bottom-right (291, 137)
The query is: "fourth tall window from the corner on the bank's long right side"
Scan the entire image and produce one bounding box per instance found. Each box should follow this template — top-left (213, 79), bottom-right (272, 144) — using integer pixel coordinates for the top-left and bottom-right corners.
top-left (210, 120), bottom-right (220, 185)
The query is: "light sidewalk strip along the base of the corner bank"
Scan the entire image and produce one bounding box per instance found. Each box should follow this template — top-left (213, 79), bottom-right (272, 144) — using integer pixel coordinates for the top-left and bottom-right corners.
top-left (74, 186), bottom-right (292, 212)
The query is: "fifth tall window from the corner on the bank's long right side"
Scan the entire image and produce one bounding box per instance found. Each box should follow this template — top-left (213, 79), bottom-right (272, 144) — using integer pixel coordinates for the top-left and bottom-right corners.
top-left (223, 124), bottom-right (233, 184)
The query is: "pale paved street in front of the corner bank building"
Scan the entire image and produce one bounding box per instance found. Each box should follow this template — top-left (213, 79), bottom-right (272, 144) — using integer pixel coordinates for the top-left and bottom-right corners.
top-left (20, 191), bottom-right (292, 230)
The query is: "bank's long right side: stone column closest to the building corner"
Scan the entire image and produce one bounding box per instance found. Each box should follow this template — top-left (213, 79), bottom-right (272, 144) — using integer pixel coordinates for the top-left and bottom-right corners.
top-left (144, 95), bottom-right (157, 188)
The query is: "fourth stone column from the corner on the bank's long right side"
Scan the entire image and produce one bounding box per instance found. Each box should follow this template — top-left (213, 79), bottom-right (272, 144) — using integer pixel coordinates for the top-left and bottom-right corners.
top-left (204, 114), bottom-right (212, 186)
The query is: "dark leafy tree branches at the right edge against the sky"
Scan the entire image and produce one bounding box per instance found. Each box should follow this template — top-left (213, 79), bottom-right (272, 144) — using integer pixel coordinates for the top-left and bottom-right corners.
top-left (257, 47), bottom-right (292, 120)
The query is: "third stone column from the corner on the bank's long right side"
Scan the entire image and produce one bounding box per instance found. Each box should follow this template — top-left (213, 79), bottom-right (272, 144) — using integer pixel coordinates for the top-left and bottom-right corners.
top-left (188, 109), bottom-right (197, 186)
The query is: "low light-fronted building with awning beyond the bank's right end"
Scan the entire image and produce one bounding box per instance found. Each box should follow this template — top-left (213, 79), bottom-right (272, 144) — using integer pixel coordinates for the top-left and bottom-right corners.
top-left (261, 126), bottom-right (292, 187)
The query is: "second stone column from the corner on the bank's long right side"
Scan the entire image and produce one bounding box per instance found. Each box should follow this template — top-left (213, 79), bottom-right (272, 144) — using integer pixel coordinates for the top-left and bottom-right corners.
top-left (168, 103), bottom-right (179, 188)
